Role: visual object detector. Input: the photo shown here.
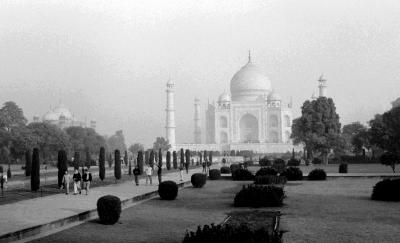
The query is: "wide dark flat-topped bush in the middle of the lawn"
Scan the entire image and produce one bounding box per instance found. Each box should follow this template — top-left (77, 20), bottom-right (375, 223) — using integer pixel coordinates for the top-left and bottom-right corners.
top-left (234, 185), bottom-right (285, 207)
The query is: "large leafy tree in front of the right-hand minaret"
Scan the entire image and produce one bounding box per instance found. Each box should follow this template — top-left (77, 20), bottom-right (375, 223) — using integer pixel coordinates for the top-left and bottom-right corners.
top-left (291, 97), bottom-right (343, 163)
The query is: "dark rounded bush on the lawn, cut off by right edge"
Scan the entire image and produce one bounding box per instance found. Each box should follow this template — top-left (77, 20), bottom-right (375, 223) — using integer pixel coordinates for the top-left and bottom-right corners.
top-left (371, 179), bottom-right (400, 201)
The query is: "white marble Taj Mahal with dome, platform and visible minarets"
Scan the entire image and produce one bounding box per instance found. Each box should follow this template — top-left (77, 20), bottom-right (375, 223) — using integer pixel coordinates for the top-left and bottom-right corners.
top-left (166, 53), bottom-right (327, 153)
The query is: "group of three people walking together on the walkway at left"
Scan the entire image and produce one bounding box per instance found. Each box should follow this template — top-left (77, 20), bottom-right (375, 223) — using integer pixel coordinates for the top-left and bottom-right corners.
top-left (61, 168), bottom-right (92, 195)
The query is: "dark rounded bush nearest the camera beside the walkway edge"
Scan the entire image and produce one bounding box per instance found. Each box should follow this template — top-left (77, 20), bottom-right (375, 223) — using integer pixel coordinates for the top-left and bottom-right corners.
top-left (97, 195), bottom-right (121, 224)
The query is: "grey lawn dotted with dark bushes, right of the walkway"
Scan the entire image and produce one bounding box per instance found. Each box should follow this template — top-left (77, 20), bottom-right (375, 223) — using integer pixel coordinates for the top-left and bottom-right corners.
top-left (32, 178), bottom-right (400, 243)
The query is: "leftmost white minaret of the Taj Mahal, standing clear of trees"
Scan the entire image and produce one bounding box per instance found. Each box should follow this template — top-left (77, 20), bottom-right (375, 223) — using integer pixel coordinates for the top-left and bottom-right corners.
top-left (165, 79), bottom-right (175, 150)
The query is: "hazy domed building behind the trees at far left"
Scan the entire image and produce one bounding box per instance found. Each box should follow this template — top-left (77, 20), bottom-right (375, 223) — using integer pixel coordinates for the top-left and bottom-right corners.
top-left (33, 103), bottom-right (96, 130)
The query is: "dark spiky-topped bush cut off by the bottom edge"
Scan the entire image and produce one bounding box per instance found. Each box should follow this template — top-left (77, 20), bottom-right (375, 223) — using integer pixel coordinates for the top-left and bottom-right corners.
top-left (183, 224), bottom-right (282, 243)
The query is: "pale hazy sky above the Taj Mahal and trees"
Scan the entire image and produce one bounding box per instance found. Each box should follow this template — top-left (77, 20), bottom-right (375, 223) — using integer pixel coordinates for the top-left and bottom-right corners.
top-left (0, 0), bottom-right (400, 145)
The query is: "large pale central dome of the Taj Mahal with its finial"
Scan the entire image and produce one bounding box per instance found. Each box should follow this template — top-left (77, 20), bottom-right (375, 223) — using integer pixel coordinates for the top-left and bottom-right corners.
top-left (231, 56), bottom-right (271, 101)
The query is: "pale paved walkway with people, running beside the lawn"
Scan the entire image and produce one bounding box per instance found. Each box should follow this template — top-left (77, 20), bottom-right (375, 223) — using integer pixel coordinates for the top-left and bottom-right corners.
top-left (0, 168), bottom-right (202, 239)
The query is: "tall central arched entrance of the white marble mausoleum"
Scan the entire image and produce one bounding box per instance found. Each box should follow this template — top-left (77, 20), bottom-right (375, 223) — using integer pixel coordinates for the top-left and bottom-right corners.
top-left (239, 114), bottom-right (259, 143)
